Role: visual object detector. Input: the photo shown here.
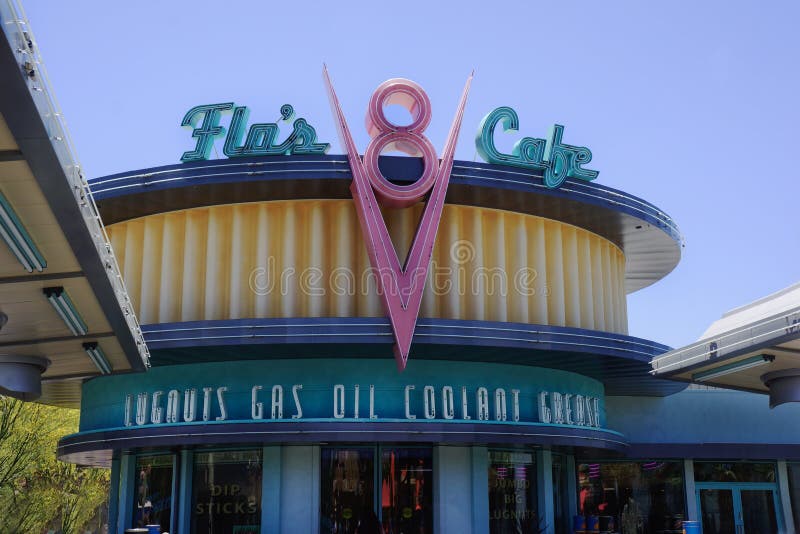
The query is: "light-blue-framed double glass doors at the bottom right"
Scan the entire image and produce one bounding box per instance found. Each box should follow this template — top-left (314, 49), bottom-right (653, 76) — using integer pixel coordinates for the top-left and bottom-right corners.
top-left (697, 485), bottom-right (778, 534)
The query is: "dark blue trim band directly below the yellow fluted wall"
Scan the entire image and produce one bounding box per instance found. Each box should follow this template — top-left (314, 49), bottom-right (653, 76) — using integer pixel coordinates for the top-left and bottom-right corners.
top-left (142, 317), bottom-right (686, 396)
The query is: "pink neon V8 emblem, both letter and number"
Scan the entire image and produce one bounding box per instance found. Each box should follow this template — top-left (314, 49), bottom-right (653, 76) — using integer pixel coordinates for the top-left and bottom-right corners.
top-left (324, 68), bottom-right (472, 371)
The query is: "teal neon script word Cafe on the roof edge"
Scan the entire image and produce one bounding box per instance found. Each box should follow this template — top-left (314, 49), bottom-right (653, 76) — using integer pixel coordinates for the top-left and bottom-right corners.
top-left (475, 106), bottom-right (599, 189)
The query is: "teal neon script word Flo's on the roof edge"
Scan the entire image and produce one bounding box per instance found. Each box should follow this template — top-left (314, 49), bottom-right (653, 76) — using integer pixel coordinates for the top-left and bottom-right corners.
top-left (181, 102), bottom-right (331, 163)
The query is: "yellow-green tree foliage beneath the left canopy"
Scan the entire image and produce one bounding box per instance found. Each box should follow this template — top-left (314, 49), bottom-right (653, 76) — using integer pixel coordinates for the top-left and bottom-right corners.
top-left (0, 396), bottom-right (109, 534)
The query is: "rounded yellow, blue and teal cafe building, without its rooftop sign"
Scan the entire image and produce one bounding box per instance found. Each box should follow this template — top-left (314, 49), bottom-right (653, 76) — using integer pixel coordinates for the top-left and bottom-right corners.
top-left (60, 148), bottom-right (800, 533)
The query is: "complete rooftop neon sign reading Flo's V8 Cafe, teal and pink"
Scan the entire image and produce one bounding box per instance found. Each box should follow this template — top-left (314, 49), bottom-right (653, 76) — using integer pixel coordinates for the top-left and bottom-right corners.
top-left (181, 82), bottom-right (599, 371)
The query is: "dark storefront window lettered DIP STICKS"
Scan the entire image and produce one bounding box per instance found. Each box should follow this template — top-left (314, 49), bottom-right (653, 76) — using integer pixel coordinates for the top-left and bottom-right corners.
top-left (192, 450), bottom-right (261, 534)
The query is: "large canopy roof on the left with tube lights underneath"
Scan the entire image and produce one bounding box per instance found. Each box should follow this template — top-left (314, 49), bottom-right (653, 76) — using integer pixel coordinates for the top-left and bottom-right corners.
top-left (0, 2), bottom-right (149, 407)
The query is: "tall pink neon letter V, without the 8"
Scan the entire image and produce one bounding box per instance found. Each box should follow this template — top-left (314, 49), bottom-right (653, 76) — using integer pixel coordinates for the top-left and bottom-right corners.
top-left (323, 67), bottom-right (472, 371)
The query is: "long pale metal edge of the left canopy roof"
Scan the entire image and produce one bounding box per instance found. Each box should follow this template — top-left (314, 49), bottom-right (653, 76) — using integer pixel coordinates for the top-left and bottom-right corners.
top-left (0, 0), bottom-right (149, 370)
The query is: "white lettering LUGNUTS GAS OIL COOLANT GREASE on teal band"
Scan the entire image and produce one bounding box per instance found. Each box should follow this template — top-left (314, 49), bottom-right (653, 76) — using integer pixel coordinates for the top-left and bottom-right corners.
top-left (120, 383), bottom-right (602, 428)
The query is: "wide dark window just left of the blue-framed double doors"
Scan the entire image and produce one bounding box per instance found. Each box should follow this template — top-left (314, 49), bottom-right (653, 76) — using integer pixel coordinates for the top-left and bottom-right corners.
top-left (578, 461), bottom-right (686, 534)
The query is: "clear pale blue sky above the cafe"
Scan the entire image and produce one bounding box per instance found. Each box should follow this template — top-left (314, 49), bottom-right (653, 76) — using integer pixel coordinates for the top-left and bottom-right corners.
top-left (23, 0), bottom-right (800, 346)
